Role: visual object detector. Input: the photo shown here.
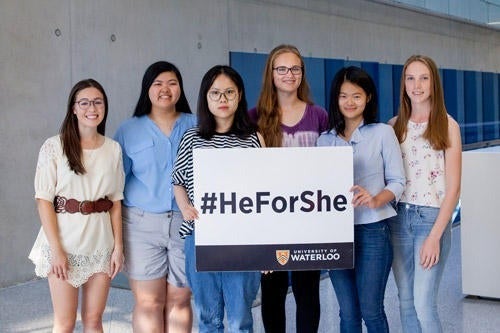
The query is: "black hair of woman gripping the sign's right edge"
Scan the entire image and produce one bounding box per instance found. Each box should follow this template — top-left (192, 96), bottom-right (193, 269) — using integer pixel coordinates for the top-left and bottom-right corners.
top-left (328, 66), bottom-right (378, 135)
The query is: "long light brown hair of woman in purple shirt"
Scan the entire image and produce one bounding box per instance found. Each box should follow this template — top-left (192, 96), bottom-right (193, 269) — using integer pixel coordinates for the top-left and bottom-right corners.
top-left (257, 44), bottom-right (312, 147)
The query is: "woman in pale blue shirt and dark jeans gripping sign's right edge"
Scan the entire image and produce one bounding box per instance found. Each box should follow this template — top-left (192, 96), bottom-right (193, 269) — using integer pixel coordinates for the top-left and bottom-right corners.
top-left (317, 66), bottom-right (405, 333)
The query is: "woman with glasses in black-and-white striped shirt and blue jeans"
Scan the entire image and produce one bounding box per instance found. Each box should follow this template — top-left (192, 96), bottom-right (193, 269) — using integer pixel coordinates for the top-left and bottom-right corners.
top-left (172, 65), bottom-right (264, 333)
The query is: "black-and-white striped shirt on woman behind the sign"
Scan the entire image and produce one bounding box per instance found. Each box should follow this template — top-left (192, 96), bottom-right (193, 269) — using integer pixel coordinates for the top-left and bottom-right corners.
top-left (172, 127), bottom-right (261, 238)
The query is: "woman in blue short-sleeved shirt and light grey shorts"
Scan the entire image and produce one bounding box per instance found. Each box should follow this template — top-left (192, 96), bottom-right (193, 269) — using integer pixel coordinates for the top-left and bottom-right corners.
top-left (115, 61), bottom-right (196, 332)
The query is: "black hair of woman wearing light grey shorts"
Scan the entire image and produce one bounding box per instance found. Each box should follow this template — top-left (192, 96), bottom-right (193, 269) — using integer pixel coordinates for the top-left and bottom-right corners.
top-left (134, 61), bottom-right (191, 117)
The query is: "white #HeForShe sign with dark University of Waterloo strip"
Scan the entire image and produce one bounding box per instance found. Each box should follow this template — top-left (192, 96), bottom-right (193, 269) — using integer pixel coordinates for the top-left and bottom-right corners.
top-left (193, 147), bottom-right (354, 271)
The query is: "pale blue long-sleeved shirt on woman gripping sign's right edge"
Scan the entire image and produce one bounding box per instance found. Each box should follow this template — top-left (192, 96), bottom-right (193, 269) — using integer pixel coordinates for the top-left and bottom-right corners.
top-left (317, 123), bottom-right (406, 224)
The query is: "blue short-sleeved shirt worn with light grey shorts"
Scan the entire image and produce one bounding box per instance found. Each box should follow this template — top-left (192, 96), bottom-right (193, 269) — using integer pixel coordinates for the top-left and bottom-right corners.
top-left (114, 113), bottom-right (196, 213)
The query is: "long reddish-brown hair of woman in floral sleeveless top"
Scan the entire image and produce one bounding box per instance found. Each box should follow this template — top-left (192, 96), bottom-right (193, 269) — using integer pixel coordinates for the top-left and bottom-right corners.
top-left (394, 55), bottom-right (450, 150)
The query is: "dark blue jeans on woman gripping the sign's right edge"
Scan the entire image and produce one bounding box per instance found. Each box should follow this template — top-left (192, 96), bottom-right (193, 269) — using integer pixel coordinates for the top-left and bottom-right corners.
top-left (329, 220), bottom-right (392, 333)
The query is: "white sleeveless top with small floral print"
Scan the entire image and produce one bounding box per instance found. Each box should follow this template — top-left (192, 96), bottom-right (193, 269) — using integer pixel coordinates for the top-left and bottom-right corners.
top-left (400, 121), bottom-right (445, 207)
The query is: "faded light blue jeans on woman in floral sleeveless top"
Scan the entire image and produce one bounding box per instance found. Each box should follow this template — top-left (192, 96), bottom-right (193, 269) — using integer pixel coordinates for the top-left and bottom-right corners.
top-left (389, 203), bottom-right (451, 333)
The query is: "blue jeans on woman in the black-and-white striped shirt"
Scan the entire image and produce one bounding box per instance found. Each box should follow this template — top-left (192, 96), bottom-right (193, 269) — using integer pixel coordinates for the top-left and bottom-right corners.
top-left (185, 234), bottom-right (260, 333)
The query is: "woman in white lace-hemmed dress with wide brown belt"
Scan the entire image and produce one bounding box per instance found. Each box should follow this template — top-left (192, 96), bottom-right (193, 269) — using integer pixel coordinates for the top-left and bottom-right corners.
top-left (29, 79), bottom-right (124, 332)
